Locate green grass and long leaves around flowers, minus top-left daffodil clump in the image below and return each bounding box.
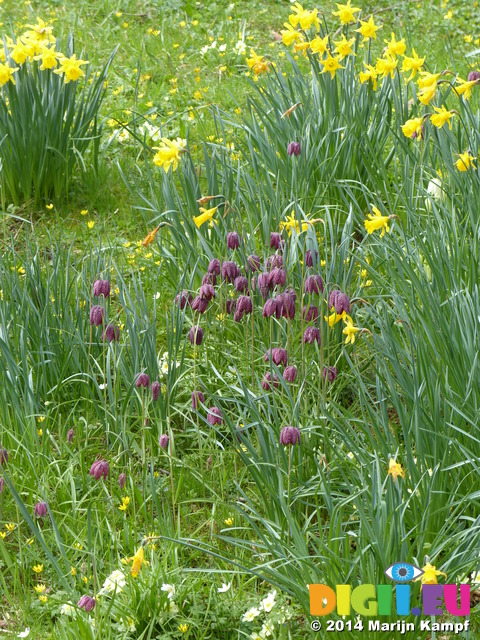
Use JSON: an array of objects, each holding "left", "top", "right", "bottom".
[{"left": 0, "top": 0, "right": 480, "bottom": 640}]
